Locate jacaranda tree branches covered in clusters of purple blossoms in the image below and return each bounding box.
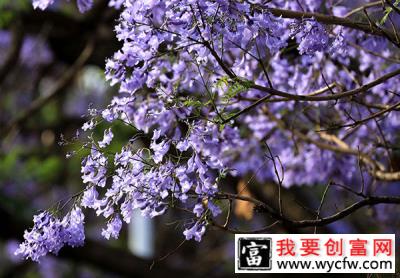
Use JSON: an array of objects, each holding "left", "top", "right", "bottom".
[{"left": 8, "top": 0, "right": 400, "bottom": 261}]
